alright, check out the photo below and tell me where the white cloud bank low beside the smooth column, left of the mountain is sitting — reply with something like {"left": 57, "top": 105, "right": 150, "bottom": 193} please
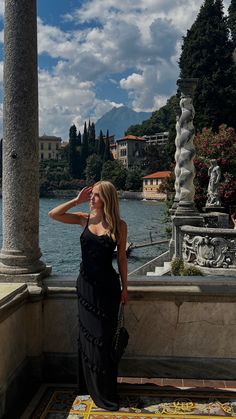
{"left": 39, "top": 71, "right": 121, "bottom": 139}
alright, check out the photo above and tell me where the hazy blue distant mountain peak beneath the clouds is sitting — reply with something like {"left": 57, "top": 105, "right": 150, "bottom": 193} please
{"left": 95, "top": 106, "right": 151, "bottom": 140}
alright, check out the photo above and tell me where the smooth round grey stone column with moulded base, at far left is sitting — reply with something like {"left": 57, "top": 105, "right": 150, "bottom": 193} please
{"left": 0, "top": 0, "right": 49, "bottom": 282}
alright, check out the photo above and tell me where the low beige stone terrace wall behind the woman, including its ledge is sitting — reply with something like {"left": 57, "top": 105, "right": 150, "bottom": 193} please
{"left": 0, "top": 276, "right": 236, "bottom": 417}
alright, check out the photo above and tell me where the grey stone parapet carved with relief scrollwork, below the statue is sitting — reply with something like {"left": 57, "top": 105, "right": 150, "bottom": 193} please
{"left": 181, "top": 226, "right": 236, "bottom": 269}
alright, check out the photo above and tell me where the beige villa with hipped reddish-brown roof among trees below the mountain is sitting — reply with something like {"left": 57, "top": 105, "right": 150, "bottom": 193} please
{"left": 116, "top": 135, "right": 146, "bottom": 169}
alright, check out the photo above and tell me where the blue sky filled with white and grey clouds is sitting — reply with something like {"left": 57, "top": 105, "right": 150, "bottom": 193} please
{"left": 0, "top": 0, "right": 230, "bottom": 140}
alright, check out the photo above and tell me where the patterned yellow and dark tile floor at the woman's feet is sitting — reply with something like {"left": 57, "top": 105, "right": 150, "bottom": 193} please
{"left": 21, "top": 377, "right": 236, "bottom": 419}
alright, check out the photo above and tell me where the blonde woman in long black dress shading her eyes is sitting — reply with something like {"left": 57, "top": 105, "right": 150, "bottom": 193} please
{"left": 49, "top": 181, "right": 128, "bottom": 410}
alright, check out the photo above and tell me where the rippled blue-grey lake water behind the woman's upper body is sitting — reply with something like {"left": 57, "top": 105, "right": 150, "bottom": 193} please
{"left": 0, "top": 198, "right": 167, "bottom": 275}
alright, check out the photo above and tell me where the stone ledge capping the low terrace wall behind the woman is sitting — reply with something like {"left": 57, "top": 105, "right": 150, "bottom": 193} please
{"left": 0, "top": 275, "right": 236, "bottom": 321}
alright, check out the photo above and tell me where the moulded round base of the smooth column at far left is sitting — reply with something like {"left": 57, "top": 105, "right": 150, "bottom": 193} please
{"left": 0, "top": 263, "right": 52, "bottom": 285}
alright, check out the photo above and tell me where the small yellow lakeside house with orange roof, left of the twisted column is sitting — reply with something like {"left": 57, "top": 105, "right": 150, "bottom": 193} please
{"left": 143, "top": 170, "right": 171, "bottom": 200}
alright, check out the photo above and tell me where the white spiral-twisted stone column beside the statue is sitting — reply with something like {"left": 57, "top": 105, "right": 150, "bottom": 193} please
{"left": 169, "top": 79, "right": 203, "bottom": 258}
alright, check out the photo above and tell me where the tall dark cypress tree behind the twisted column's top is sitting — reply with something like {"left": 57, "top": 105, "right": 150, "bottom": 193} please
{"left": 179, "top": 0, "right": 236, "bottom": 131}
